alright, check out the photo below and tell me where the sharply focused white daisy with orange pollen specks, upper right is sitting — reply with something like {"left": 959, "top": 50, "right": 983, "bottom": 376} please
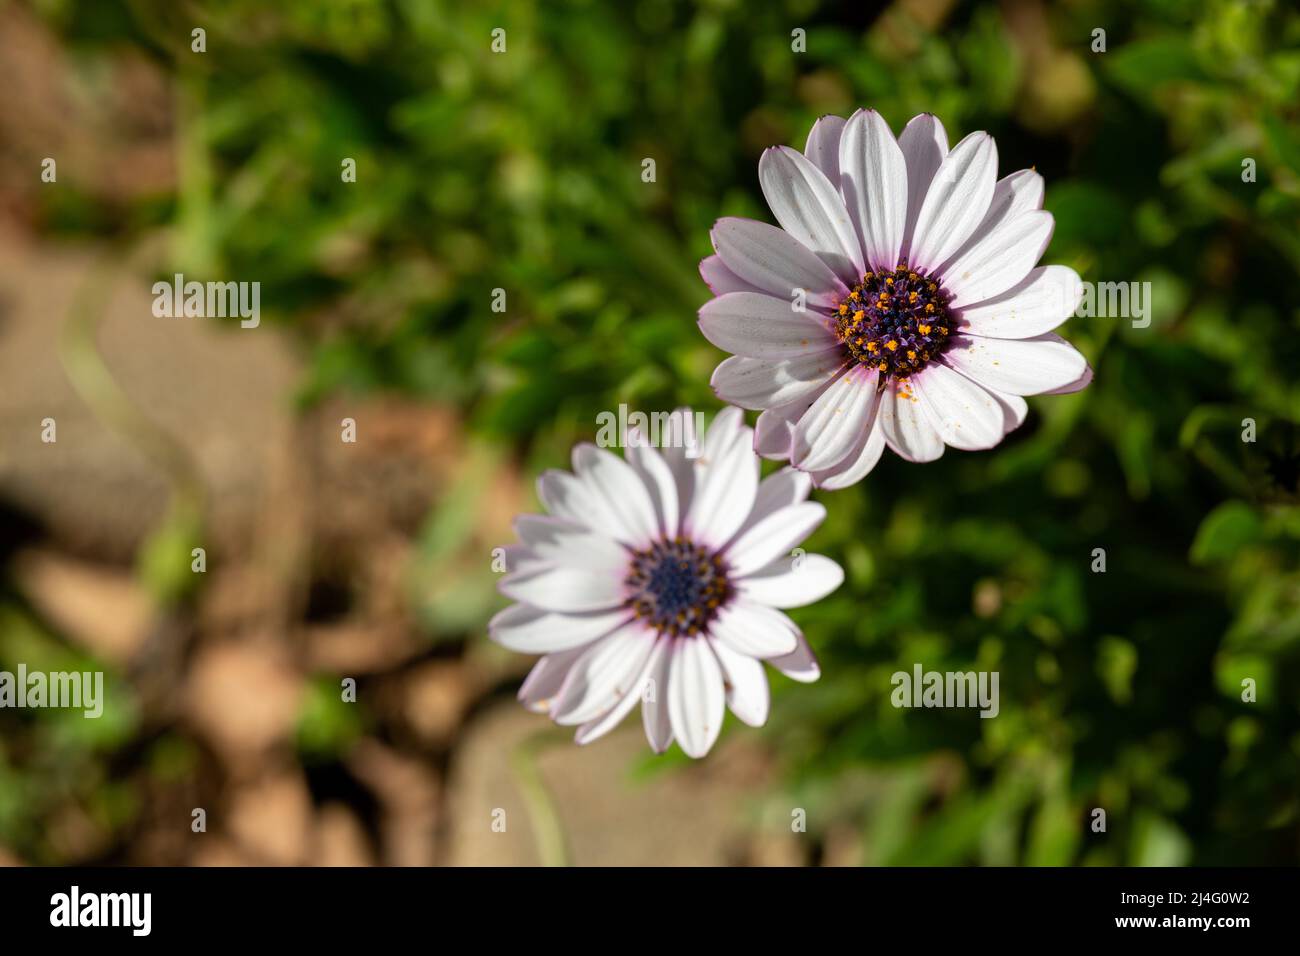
{"left": 699, "top": 111, "right": 1092, "bottom": 488}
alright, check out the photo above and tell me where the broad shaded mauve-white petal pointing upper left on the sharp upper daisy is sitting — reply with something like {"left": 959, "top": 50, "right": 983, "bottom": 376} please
{"left": 711, "top": 217, "right": 849, "bottom": 311}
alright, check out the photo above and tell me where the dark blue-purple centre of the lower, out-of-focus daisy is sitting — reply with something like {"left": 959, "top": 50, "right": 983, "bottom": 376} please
{"left": 624, "top": 537, "right": 731, "bottom": 637}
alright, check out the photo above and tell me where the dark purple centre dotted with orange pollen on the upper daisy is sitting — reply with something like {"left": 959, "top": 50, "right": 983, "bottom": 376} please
{"left": 835, "top": 263, "right": 952, "bottom": 389}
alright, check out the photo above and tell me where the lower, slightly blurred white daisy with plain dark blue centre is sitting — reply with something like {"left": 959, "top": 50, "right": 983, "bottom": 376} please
{"left": 489, "top": 408, "right": 844, "bottom": 757}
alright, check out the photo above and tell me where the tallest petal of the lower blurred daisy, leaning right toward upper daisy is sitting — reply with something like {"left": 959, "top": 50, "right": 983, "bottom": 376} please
{"left": 685, "top": 408, "right": 759, "bottom": 548}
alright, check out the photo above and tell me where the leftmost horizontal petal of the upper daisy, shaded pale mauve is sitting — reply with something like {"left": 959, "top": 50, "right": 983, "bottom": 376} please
{"left": 699, "top": 293, "right": 839, "bottom": 359}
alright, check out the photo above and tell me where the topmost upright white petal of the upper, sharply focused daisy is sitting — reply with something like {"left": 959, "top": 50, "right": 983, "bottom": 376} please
{"left": 840, "top": 109, "right": 907, "bottom": 269}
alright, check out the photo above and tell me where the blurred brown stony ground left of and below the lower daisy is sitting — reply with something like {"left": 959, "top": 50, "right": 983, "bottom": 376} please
{"left": 0, "top": 226, "right": 797, "bottom": 865}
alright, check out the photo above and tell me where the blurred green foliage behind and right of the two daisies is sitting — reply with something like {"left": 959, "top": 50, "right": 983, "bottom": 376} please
{"left": 17, "top": 0, "right": 1300, "bottom": 864}
